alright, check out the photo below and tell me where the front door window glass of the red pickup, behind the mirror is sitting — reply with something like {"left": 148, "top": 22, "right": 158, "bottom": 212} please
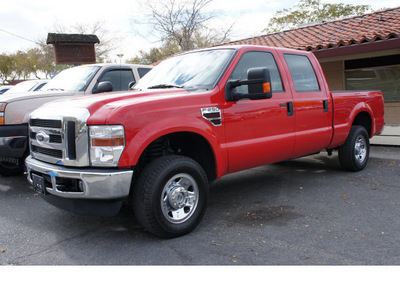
{"left": 229, "top": 51, "right": 284, "bottom": 94}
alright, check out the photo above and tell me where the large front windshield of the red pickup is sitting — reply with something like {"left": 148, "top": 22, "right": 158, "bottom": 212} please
{"left": 135, "top": 49, "right": 235, "bottom": 89}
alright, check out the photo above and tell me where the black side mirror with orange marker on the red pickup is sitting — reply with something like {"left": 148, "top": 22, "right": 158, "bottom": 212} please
{"left": 225, "top": 68, "right": 272, "bottom": 101}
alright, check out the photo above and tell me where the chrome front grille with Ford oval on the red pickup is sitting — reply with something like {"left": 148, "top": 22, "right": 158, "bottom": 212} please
{"left": 29, "top": 109, "right": 89, "bottom": 167}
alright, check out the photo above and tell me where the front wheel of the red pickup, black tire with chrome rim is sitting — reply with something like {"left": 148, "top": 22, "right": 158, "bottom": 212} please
{"left": 133, "top": 155, "right": 208, "bottom": 238}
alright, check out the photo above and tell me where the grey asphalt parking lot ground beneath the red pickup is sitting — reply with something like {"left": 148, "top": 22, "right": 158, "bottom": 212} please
{"left": 0, "top": 146, "right": 400, "bottom": 266}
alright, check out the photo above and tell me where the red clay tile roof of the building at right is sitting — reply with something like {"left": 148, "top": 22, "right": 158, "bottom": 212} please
{"left": 220, "top": 7, "right": 400, "bottom": 51}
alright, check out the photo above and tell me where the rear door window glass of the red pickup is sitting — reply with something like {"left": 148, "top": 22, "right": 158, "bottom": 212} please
{"left": 284, "top": 54, "right": 320, "bottom": 92}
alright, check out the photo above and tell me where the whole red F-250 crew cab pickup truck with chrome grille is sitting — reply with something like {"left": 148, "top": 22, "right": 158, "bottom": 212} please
{"left": 26, "top": 46, "right": 384, "bottom": 238}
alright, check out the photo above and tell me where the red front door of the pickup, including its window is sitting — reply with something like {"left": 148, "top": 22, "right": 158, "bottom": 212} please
{"left": 223, "top": 51, "right": 295, "bottom": 173}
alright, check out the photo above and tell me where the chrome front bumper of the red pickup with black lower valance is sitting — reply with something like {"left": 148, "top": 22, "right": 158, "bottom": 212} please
{"left": 25, "top": 156, "right": 133, "bottom": 216}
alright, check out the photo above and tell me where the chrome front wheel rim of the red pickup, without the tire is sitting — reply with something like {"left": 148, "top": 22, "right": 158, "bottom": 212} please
{"left": 161, "top": 173, "right": 199, "bottom": 224}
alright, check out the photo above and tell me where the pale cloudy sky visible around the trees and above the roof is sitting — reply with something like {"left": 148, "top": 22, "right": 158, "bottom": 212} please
{"left": 0, "top": 0, "right": 399, "bottom": 62}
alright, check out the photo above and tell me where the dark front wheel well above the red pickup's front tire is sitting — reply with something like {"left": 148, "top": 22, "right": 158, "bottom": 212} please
{"left": 136, "top": 132, "right": 217, "bottom": 181}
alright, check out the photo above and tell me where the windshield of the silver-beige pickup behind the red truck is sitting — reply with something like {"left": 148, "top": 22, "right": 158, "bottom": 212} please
{"left": 40, "top": 66, "right": 100, "bottom": 92}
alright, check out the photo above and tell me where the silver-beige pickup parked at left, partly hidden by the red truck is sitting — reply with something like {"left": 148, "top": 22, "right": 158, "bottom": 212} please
{"left": 0, "top": 64, "right": 152, "bottom": 176}
